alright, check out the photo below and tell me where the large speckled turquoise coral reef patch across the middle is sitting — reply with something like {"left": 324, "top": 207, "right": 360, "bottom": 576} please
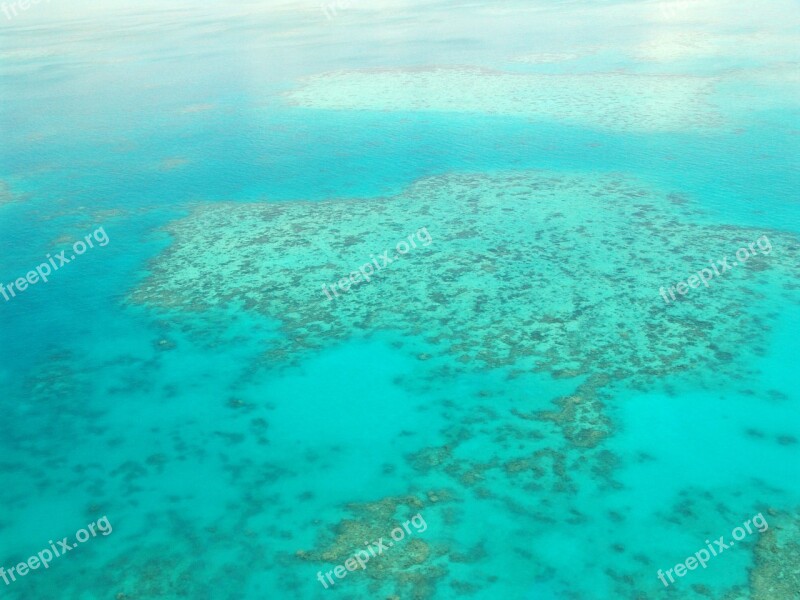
{"left": 132, "top": 172, "right": 800, "bottom": 446}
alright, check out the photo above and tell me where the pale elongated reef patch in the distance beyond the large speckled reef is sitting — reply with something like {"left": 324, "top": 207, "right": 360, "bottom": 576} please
{"left": 287, "top": 67, "right": 722, "bottom": 132}
